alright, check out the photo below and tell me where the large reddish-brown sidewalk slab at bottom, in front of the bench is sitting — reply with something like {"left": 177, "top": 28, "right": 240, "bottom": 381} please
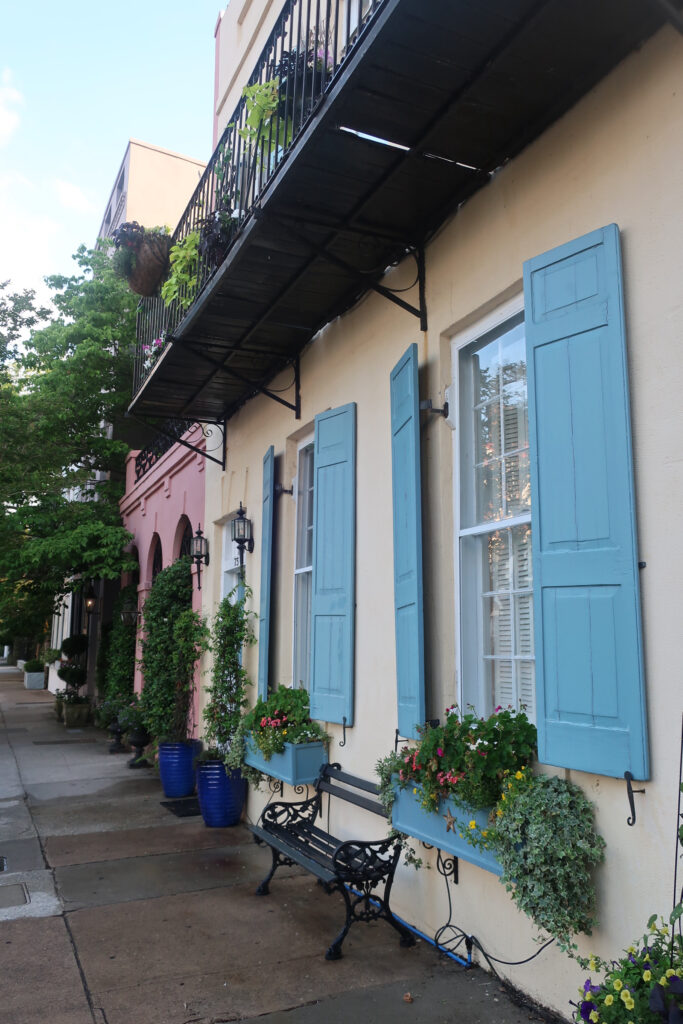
{"left": 69, "top": 876, "right": 444, "bottom": 1024}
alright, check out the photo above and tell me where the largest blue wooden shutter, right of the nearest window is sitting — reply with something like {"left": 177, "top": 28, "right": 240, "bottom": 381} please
{"left": 524, "top": 224, "right": 648, "bottom": 779}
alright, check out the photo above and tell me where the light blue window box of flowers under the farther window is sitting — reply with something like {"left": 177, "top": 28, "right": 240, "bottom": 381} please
{"left": 229, "top": 686, "right": 330, "bottom": 785}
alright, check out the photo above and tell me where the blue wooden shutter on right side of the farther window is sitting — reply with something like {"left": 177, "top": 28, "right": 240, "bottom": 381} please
{"left": 310, "top": 403, "right": 355, "bottom": 725}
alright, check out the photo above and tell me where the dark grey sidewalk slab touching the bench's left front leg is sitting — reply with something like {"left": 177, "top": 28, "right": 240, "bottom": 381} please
{"left": 54, "top": 845, "right": 292, "bottom": 910}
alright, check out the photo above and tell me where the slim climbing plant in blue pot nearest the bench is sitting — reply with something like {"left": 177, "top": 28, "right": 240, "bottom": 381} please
{"left": 197, "top": 589, "right": 256, "bottom": 827}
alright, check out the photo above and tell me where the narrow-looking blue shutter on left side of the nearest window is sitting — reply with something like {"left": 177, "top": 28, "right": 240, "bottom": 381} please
{"left": 391, "top": 345, "right": 425, "bottom": 737}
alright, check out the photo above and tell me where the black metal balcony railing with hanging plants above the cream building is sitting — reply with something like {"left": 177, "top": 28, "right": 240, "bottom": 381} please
{"left": 134, "top": 0, "right": 378, "bottom": 393}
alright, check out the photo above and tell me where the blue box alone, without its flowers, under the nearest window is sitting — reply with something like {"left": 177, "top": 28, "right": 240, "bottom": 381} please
{"left": 391, "top": 788, "right": 503, "bottom": 874}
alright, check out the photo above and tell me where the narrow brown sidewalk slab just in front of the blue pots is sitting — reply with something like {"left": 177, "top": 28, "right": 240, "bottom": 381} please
{"left": 46, "top": 817, "right": 251, "bottom": 867}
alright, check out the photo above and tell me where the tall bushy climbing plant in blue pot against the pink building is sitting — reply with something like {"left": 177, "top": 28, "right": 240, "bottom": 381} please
{"left": 140, "top": 557, "right": 208, "bottom": 798}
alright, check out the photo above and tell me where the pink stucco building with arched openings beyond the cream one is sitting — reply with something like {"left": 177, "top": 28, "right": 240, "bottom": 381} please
{"left": 120, "top": 423, "right": 206, "bottom": 734}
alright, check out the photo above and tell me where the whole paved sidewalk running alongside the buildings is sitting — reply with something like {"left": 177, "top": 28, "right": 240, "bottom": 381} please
{"left": 0, "top": 667, "right": 557, "bottom": 1024}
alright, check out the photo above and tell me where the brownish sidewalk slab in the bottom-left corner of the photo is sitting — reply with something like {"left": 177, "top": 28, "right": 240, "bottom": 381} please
{"left": 0, "top": 918, "right": 92, "bottom": 1024}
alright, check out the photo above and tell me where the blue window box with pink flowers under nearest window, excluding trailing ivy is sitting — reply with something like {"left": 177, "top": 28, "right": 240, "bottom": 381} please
{"left": 391, "top": 705, "right": 536, "bottom": 874}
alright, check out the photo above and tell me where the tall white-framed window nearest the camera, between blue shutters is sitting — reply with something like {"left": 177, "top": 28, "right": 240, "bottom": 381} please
{"left": 453, "top": 296, "right": 536, "bottom": 720}
